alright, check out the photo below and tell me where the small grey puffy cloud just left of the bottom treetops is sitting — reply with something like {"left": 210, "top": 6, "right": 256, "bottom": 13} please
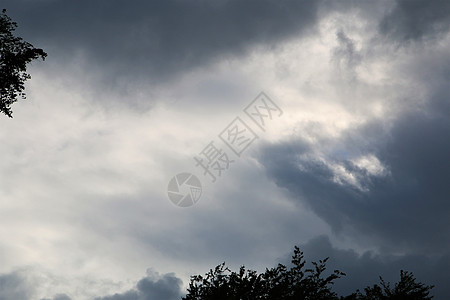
{"left": 95, "top": 273, "right": 183, "bottom": 300}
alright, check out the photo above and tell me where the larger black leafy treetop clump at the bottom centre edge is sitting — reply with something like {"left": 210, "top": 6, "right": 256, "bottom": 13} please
{"left": 183, "top": 247, "right": 345, "bottom": 300}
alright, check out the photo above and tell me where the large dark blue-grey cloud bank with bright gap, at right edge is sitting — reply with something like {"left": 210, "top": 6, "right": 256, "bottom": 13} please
{"left": 260, "top": 99, "right": 450, "bottom": 253}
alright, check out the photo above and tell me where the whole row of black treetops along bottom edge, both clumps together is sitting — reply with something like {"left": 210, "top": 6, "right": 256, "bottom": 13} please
{"left": 183, "top": 247, "right": 433, "bottom": 300}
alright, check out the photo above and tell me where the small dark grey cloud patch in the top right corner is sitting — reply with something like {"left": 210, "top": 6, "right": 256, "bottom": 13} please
{"left": 380, "top": 0, "right": 450, "bottom": 42}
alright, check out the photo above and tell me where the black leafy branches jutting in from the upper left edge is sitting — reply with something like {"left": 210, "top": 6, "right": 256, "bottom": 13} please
{"left": 0, "top": 9, "right": 47, "bottom": 118}
